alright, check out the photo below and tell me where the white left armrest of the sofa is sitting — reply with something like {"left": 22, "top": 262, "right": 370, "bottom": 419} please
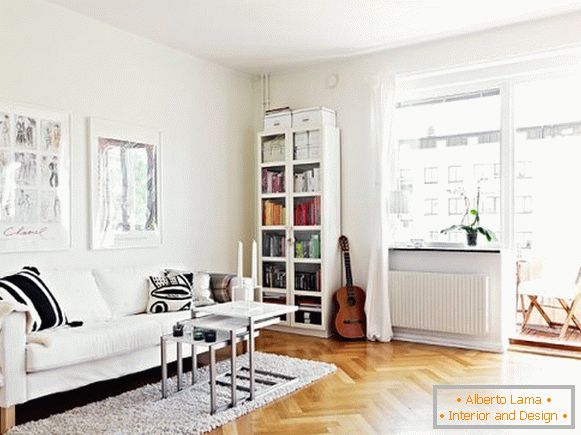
{"left": 0, "top": 312, "right": 26, "bottom": 408}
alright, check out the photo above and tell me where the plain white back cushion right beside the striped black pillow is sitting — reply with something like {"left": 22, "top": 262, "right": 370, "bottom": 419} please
{"left": 42, "top": 269, "right": 113, "bottom": 324}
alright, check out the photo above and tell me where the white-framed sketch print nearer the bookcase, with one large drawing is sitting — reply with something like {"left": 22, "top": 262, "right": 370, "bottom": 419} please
{"left": 89, "top": 118, "right": 161, "bottom": 249}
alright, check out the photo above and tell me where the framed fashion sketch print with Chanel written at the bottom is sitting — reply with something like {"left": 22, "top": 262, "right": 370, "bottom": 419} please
{"left": 0, "top": 102, "right": 70, "bottom": 253}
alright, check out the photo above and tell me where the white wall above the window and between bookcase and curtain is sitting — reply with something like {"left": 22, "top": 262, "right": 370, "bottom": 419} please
{"left": 271, "top": 13, "right": 581, "bottom": 285}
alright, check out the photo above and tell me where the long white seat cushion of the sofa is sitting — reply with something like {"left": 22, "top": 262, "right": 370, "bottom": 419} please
{"left": 26, "top": 316, "right": 162, "bottom": 373}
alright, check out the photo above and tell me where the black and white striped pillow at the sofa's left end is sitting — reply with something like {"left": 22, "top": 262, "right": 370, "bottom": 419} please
{"left": 0, "top": 267, "right": 67, "bottom": 332}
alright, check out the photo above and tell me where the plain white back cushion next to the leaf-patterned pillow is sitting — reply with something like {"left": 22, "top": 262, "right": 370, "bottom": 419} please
{"left": 94, "top": 266, "right": 162, "bottom": 317}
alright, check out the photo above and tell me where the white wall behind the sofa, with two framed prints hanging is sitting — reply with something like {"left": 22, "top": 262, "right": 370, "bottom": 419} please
{"left": 0, "top": 0, "right": 256, "bottom": 271}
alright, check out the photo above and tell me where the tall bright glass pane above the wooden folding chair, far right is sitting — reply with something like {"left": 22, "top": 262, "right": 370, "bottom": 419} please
{"left": 513, "top": 73, "right": 581, "bottom": 252}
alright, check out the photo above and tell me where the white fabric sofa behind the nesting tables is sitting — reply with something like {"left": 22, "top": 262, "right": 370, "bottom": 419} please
{"left": 0, "top": 266, "right": 231, "bottom": 427}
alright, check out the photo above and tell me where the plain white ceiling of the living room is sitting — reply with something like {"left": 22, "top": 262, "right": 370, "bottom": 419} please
{"left": 49, "top": 0, "right": 581, "bottom": 73}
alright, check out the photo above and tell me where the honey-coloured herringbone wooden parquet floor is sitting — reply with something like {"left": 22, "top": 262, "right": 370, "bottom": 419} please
{"left": 212, "top": 332, "right": 581, "bottom": 435}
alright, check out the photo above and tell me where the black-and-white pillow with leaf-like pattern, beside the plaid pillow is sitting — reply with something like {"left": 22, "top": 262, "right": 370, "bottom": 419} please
{"left": 147, "top": 275, "right": 192, "bottom": 313}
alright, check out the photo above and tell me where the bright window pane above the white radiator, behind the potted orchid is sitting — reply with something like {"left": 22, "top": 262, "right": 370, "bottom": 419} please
{"left": 393, "top": 89, "right": 500, "bottom": 243}
